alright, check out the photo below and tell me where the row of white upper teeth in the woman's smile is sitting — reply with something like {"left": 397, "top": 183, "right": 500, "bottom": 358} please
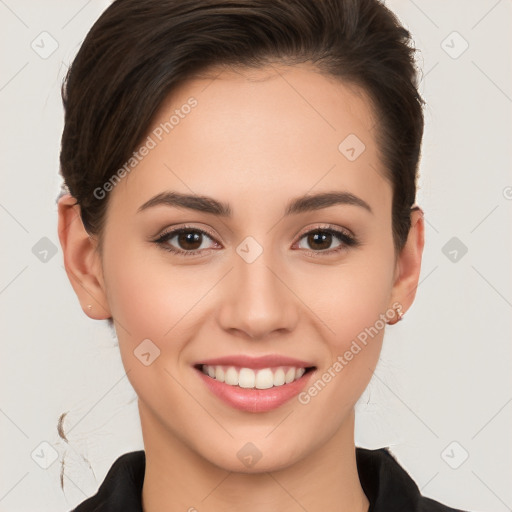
{"left": 202, "top": 364, "right": 306, "bottom": 389}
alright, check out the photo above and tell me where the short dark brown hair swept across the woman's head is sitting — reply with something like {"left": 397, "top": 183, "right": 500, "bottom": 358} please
{"left": 60, "top": 0, "right": 423, "bottom": 253}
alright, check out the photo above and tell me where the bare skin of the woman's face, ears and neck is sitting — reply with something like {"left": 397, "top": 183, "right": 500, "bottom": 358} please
{"left": 59, "top": 64, "right": 424, "bottom": 512}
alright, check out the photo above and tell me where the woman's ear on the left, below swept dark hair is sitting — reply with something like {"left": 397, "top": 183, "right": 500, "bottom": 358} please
{"left": 58, "top": 194, "right": 111, "bottom": 320}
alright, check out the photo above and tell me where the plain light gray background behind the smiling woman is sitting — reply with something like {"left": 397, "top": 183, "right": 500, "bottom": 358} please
{"left": 0, "top": 0, "right": 512, "bottom": 512}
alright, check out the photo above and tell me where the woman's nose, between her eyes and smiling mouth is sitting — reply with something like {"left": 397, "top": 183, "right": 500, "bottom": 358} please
{"left": 218, "top": 251, "right": 300, "bottom": 340}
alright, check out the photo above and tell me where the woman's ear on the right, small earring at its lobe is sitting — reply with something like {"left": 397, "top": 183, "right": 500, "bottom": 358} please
{"left": 390, "top": 207, "right": 425, "bottom": 313}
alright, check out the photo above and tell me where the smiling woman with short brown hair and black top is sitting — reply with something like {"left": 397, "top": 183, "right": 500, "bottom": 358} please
{"left": 59, "top": 0, "right": 470, "bottom": 512}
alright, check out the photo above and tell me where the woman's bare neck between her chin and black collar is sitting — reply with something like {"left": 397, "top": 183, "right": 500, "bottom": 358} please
{"left": 139, "top": 405, "right": 369, "bottom": 512}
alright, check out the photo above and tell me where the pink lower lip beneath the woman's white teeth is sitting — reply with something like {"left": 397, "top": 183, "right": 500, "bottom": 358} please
{"left": 194, "top": 368, "right": 315, "bottom": 412}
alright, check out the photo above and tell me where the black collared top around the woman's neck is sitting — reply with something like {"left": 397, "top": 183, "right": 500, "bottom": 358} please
{"left": 71, "top": 447, "right": 470, "bottom": 512}
